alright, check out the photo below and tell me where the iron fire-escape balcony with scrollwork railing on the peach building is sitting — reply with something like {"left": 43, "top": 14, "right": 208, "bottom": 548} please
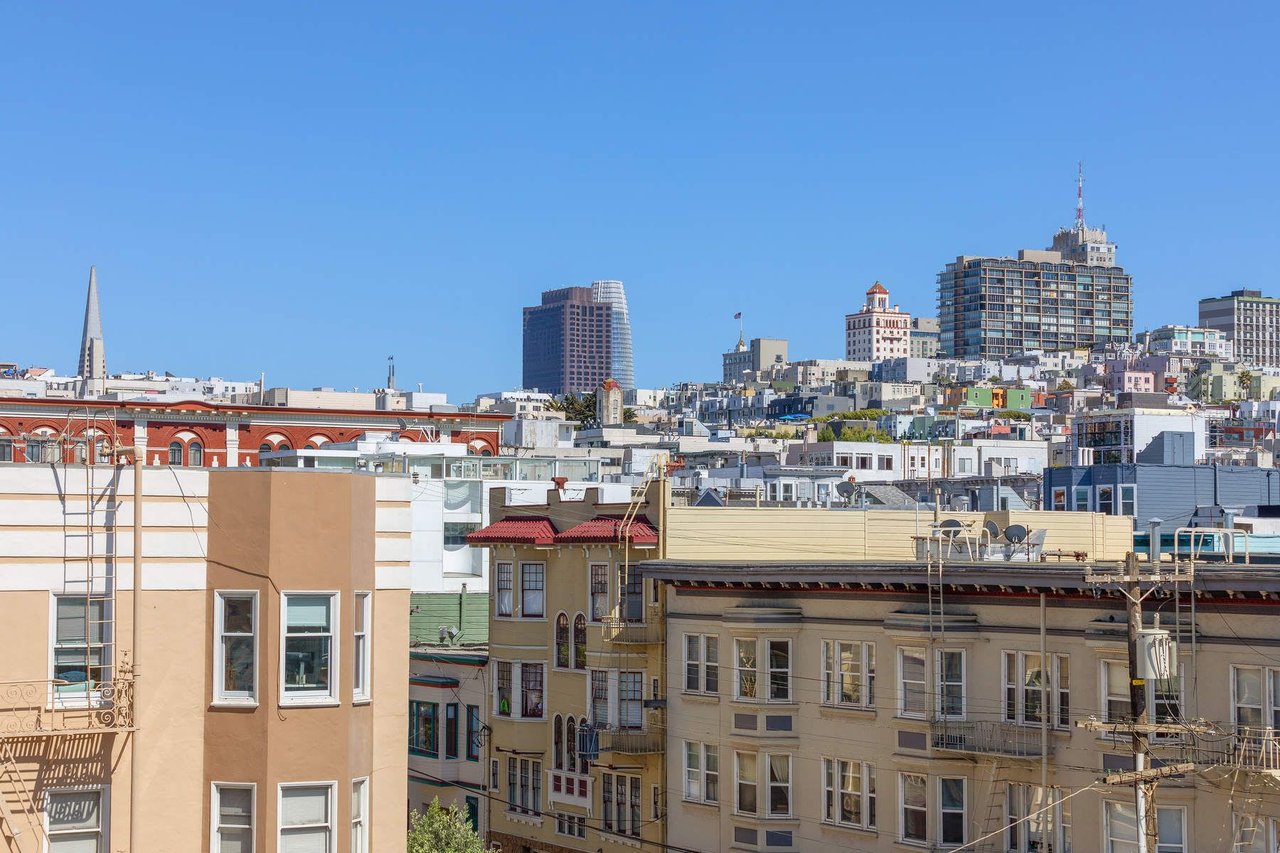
{"left": 0, "top": 679, "right": 133, "bottom": 736}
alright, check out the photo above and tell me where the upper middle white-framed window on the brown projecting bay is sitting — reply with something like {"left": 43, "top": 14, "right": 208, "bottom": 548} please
{"left": 280, "top": 593, "right": 338, "bottom": 704}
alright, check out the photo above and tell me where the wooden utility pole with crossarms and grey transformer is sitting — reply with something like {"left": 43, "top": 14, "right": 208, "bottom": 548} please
{"left": 1075, "top": 535, "right": 1208, "bottom": 853}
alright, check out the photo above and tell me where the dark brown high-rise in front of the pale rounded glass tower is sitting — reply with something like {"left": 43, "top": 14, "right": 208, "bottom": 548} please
{"left": 524, "top": 287, "right": 614, "bottom": 394}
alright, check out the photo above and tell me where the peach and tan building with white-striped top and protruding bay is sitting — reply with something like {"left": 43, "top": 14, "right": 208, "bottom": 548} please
{"left": 0, "top": 458, "right": 410, "bottom": 853}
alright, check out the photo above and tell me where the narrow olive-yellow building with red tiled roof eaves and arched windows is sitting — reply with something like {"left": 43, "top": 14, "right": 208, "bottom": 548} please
{"left": 468, "top": 487, "right": 666, "bottom": 853}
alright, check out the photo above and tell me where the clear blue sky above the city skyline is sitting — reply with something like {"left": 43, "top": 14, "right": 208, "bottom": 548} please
{"left": 0, "top": 1, "right": 1280, "bottom": 400}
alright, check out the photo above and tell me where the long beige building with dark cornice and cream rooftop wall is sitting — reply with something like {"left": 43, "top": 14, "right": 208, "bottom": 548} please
{"left": 643, "top": 507, "right": 1280, "bottom": 853}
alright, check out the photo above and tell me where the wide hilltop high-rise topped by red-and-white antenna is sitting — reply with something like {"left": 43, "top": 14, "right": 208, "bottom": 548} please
{"left": 938, "top": 171, "right": 1136, "bottom": 359}
